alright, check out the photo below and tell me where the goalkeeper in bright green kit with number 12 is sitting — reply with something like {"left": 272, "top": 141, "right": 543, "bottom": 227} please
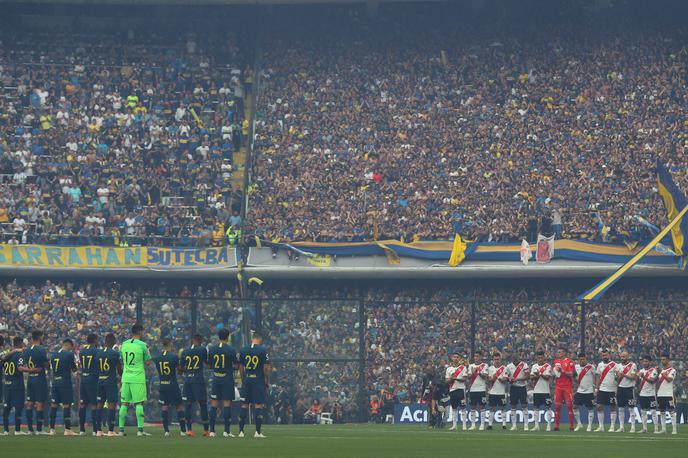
{"left": 119, "top": 323, "right": 151, "bottom": 436}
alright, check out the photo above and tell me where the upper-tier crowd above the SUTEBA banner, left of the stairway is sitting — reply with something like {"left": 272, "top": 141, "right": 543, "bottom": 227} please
{"left": 0, "top": 28, "right": 246, "bottom": 246}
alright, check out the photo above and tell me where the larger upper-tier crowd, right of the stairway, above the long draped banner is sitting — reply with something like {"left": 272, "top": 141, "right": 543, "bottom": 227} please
{"left": 247, "top": 13, "right": 688, "bottom": 242}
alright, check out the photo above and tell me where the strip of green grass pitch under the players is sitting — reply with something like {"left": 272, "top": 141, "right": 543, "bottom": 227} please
{"left": 0, "top": 424, "right": 688, "bottom": 458}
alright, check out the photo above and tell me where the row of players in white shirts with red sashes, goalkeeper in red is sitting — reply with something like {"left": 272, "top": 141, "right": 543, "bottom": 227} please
{"left": 426, "top": 348, "right": 677, "bottom": 434}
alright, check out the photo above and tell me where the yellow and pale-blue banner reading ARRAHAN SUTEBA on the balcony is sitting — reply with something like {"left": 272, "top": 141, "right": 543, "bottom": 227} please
{"left": 0, "top": 245, "right": 236, "bottom": 269}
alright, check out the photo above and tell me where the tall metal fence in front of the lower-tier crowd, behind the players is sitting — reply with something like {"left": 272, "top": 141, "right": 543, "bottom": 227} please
{"left": 136, "top": 297, "right": 688, "bottom": 421}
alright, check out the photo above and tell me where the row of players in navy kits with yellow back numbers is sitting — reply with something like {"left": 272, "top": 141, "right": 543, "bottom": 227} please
{"left": 0, "top": 329, "right": 270, "bottom": 437}
